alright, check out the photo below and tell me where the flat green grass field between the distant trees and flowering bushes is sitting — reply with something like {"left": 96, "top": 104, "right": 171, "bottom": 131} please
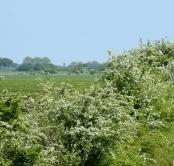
{"left": 0, "top": 73, "right": 96, "bottom": 93}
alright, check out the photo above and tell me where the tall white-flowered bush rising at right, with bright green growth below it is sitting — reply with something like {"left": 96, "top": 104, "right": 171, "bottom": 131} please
{"left": 101, "top": 41, "right": 174, "bottom": 166}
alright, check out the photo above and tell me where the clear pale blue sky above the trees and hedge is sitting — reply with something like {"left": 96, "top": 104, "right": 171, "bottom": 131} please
{"left": 0, "top": 0, "right": 174, "bottom": 65}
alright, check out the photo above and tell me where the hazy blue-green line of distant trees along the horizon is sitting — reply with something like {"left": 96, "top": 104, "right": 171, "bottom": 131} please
{"left": 0, "top": 56, "right": 106, "bottom": 74}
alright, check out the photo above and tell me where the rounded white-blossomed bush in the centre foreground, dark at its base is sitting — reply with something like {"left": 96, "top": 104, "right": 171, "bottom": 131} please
{"left": 49, "top": 86, "right": 134, "bottom": 165}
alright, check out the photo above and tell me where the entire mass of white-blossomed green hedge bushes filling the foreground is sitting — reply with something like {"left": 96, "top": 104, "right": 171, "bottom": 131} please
{"left": 0, "top": 41, "right": 174, "bottom": 166}
